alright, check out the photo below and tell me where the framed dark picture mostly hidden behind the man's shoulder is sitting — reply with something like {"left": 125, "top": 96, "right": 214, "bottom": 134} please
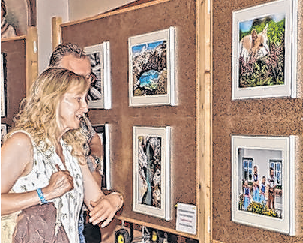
{"left": 93, "top": 123, "right": 112, "bottom": 190}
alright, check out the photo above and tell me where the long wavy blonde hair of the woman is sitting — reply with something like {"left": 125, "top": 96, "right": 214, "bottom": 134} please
{"left": 7, "top": 68, "right": 89, "bottom": 160}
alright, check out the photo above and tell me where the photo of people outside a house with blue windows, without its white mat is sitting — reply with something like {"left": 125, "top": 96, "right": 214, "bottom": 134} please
{"left": 237, "top": 148, "right": 283, "bottom": 218}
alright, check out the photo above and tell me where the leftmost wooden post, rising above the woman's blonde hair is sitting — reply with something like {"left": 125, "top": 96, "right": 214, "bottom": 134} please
{"left": 26, "top": 26, "right": 38, "bottom": 97}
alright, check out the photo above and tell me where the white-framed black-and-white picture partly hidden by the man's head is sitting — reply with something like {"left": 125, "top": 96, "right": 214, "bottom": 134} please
{"left": 84, "top": 41, "right": 112, "bottom": 109}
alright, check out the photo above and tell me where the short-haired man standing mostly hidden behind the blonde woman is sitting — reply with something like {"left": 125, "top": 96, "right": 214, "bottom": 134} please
{"left": 49, "top": 44, "right": 123, "bottom": 243}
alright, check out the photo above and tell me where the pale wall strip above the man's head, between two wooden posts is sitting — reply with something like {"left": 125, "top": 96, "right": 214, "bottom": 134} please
{"left": 37, "top": 0, "right": 69, "bottom": 73}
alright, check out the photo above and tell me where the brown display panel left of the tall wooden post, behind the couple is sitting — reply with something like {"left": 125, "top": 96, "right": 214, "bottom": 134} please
{"left": 62, "top": 0, "right": 196, "bottom": 229}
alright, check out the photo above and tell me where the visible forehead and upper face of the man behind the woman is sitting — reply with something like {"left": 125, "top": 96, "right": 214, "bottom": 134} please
{"left": 60, "top": 55, "right": 91, "bottom": 84}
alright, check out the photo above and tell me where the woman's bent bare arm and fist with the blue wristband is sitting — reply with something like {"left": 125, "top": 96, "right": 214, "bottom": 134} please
{"left": 1, "top": 132, "right": 73, "bottom": 215}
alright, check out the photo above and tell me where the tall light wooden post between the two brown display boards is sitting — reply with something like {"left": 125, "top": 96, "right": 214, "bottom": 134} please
{"left": 196, "top": 0, "right": 212, "bottom": 242}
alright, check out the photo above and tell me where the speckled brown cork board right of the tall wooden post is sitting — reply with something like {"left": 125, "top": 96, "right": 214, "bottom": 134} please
{"left": 212, "top": 0, "right": 303, "bottom": 243}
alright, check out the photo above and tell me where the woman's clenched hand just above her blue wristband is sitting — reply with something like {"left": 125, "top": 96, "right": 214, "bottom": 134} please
{"left": 42, "top": 164, "right": 74, "bottom": 200}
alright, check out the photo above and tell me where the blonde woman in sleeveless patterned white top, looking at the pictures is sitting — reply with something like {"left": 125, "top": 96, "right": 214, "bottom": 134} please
{"left": 1, "top": 68, "right": 123, "bottom": 243}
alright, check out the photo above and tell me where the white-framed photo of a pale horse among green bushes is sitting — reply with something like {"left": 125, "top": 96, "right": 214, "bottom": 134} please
{"left": 232, "top": 0, "right": 298, "bottom": 100}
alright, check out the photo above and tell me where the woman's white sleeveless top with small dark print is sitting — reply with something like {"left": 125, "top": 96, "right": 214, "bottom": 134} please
{"left": 13, "top": 131, "right": 83, "bottom": 243}
